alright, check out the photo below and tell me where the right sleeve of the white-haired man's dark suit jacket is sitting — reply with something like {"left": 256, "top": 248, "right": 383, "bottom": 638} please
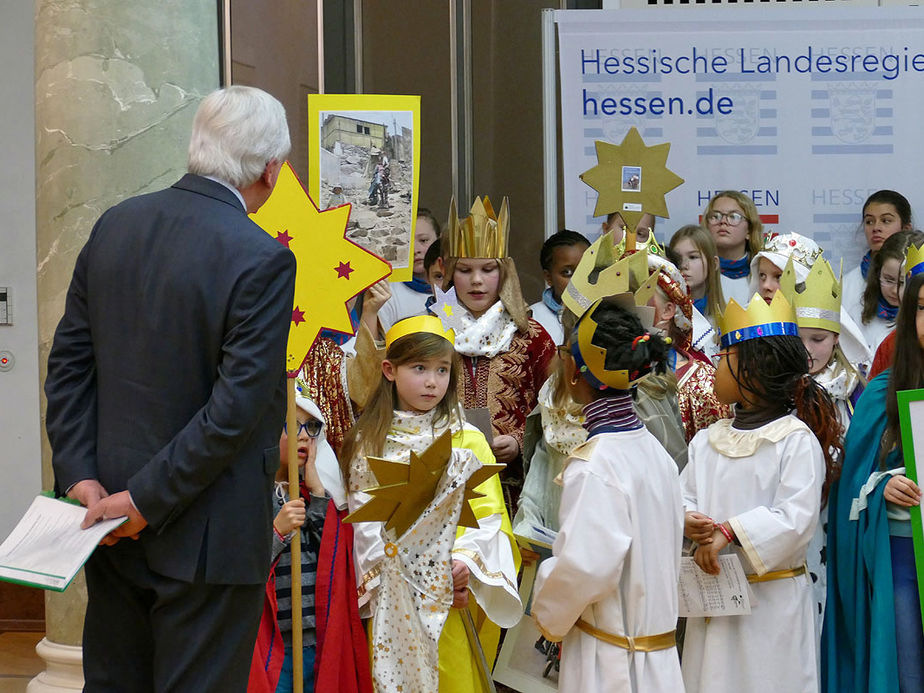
{"left": 128, "top": 252, "right": 295, "bottom": 530}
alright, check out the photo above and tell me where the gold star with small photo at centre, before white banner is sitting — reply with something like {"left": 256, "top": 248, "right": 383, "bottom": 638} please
{"left": 581, "top": 127, "right": 683, "bottom": 229}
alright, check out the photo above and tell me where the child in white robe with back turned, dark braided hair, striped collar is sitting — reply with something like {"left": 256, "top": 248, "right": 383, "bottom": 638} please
{"left": 532, "top": 298, "right": 683, "bottom": 693}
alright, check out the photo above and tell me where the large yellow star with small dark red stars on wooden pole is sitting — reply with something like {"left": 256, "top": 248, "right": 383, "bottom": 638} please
{"left": 250, "top": 162, "right": 391, "bottom": 375}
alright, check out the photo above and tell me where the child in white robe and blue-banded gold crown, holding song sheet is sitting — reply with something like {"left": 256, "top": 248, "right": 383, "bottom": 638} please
{"left": 680, "top": 292, "right": 841, "bottom": 693}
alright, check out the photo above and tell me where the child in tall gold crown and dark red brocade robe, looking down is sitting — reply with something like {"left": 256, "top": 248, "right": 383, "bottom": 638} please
{"left": 431, "top": 197, "right": 555, "bottom": 512}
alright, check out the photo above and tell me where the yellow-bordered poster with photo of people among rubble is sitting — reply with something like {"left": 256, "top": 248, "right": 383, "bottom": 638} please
{"left": 308, "top": 94, "right": 420, "bottom": 282}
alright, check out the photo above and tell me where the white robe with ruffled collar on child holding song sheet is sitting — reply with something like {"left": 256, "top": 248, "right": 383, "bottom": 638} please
{"left": 680, "top": 415, "right": 825, "bottom": 693}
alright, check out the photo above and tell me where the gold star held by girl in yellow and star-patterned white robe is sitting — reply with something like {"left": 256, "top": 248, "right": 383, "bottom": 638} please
{"left": 343, "top": 430, "right": 504, "bottom": 537}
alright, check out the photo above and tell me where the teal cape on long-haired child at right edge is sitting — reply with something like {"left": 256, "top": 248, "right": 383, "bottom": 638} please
{"left": 821, "top": 370, "right": 901, "bottom": 693}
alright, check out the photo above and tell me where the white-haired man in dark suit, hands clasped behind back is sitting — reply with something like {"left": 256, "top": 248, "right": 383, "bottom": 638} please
{"left": 45, "top": 87, "right": 295, "bottom": 693}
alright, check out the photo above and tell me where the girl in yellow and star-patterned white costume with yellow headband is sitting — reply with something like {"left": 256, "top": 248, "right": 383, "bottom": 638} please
{"left": 341, "top": 316, "right": 522, "bottom": 693}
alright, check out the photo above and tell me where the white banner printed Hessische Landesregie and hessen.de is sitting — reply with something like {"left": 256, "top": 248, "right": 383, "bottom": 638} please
{"left": 556, "top": 5, "right": 924, "bottom": 272}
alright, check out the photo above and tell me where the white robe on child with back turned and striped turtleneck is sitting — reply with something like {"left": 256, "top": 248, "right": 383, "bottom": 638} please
{"left": 532, "top": 428, "right": 683, "bottom": 693}
